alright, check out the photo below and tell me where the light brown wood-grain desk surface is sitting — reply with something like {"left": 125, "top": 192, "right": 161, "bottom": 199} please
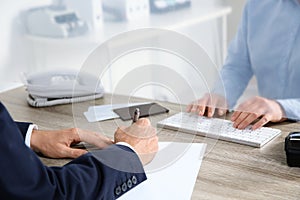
{"left": 0, "top": 88, "right": 300, "bottom": 199}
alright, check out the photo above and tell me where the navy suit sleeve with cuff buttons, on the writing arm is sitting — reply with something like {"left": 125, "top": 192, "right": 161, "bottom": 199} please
{"left": 0, "top": 103, "right": 146, "bottom": 200}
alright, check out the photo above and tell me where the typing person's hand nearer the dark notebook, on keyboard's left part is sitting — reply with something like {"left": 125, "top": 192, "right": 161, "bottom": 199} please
{"left": 187, "top": 93, "right": 228, "bottom": 117}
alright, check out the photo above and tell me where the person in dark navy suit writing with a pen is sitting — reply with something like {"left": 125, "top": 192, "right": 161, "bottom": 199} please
{"left": 0, "top": 103, "right": 158, "bottom": 200}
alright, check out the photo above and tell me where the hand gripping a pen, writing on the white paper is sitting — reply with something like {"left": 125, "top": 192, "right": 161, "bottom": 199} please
{"left": 115, "top": 118, "right": 158, "bottom": 165}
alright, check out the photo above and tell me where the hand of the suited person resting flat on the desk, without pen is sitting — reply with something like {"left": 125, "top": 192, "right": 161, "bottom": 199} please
{"left": 30, "top": 128, "right": 113, "bottom": 158}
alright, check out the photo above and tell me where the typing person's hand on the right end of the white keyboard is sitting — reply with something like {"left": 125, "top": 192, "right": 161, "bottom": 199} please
{"left": 231, "top": 97, "right": 286, "bottom": 130}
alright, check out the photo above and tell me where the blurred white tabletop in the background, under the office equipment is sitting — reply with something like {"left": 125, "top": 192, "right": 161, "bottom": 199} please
{"left": 26, "top": 1, "right": 232, "bottom": 45}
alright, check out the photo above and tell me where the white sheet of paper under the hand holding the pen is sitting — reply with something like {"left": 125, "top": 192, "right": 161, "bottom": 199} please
{"left": 119, "top": 142, "right": 206, "bottom": 200}
